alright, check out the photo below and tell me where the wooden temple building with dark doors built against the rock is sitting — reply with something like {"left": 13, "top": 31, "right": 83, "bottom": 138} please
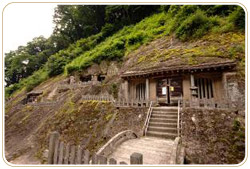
{"left": 121, "top": 57, "right": 237, "bottom": 106}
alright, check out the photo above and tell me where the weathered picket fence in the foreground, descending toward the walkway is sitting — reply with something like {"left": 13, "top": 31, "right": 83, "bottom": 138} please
{"left": 48, "top": 132, "right": 143, "bottom": 165}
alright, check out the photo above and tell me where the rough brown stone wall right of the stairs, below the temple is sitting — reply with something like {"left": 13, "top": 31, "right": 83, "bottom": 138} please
{"left": 182, "top": 108, "right": 245, "bottom": 164}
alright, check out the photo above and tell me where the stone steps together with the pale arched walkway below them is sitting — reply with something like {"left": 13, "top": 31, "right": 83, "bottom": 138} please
{"left": 99, "top": 107, "right": 185, "bottom": 165}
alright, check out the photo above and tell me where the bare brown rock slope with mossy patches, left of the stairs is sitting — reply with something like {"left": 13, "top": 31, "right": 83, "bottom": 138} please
{"left": 5, "top": 74, "right": 146, "bottom": 164}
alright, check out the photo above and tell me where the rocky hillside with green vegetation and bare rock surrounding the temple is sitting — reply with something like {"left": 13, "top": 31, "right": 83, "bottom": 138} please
{"left": 5, "top": 6, "right": 245, "bottom": 163}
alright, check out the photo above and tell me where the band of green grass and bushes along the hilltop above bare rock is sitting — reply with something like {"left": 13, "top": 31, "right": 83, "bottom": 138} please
{"left": 5, "top": 5, "right": 245, "bottom": 97}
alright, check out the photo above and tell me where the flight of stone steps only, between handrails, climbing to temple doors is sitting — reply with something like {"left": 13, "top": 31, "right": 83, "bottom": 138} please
{"left": 146, "top": 107, "right": 178, "bottom": 139}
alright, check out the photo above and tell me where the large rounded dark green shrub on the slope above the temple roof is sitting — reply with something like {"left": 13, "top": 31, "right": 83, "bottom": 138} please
{"left": 176, "top": 10, "right": 213, "bottom": 41}
